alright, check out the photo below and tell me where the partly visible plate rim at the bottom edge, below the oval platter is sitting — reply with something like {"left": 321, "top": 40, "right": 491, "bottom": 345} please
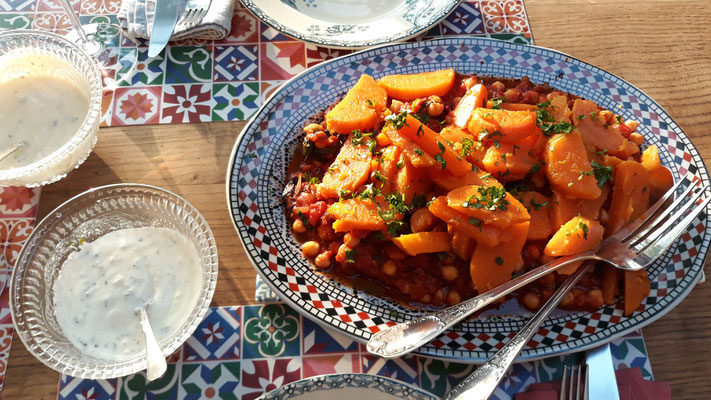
{"left": 258, "top": 374, "right": 436, "bottom": 400}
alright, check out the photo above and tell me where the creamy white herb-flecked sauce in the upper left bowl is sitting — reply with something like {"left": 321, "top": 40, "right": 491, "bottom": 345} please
{"left": 0, "top": 54, "right": 89, "bottom": 169}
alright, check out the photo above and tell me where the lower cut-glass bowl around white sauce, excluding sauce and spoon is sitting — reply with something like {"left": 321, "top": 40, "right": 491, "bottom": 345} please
{"left": 10, "top": 184, "right": 217, "bottom": 379}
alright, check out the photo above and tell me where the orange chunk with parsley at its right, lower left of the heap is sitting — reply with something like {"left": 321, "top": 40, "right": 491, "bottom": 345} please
{"left": 326, "top": 198, "right": 387, "bottom": 232}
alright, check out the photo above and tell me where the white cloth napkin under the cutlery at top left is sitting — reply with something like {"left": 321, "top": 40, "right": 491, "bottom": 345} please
{"left": 117, "top": 0, "right": 235, "bottom": 42}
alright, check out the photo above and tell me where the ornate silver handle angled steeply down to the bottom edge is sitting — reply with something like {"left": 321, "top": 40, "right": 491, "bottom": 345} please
{"left": 442, "top": 262, "right": 595, "bottom": 400}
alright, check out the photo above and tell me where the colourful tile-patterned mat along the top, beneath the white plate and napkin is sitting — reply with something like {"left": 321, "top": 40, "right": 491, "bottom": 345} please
{"left": 0, "top": 0, "right": 532, "bottom": 126}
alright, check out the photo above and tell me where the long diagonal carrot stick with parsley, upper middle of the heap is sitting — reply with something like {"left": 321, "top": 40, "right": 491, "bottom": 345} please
{"left": 398, "top": 114, "right": 471, "bottom": 176}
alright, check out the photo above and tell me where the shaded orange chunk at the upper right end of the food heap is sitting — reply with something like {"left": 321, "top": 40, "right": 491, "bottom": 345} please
{"left": 572, "top": 99, "right": 628, "bottom": 158}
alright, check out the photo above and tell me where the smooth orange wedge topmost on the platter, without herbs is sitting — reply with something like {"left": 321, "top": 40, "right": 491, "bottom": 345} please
{"left": 378, "top": 68, "right": 456, "bottom": 100}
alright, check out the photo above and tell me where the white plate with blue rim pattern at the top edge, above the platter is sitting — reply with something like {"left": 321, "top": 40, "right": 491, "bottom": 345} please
{"left": 242, "top": 0, "right": 459, "bottom": 49}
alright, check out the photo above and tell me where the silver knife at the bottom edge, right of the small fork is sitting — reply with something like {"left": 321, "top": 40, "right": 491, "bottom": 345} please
{"left": 585, "top": 343, "right": 620, "bottom": 400}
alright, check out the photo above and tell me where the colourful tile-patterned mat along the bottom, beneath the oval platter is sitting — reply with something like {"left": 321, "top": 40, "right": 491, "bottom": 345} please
{"left": 54, "top": 304, "right": 651, "bottom": 400}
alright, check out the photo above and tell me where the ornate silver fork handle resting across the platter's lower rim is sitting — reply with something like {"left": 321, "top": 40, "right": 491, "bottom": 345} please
{"left": 366, "top": 251, "right": 599, "bottom": 358}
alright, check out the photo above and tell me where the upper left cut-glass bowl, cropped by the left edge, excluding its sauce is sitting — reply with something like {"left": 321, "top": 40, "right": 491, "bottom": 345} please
{"left": 0, "top": 30, "right": 102, "bottom": 187}
